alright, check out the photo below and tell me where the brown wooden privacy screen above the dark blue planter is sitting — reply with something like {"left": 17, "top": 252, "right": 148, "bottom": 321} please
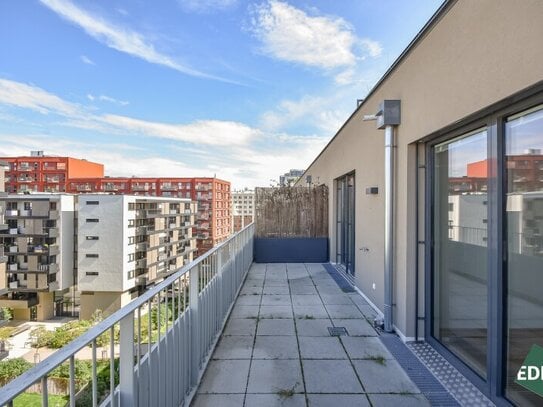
{"left": 255, "top": 185, "right": 328, "bottom": 238}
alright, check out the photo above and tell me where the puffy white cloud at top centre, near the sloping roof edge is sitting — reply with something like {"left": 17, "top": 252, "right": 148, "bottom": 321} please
{"left": 251, "top": 0, "right": 381, "bottom": 70}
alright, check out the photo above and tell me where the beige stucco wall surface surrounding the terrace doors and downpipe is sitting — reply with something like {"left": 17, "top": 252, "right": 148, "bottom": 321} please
{"left": 304, "top": 0, "right": 543, "bottom": 337}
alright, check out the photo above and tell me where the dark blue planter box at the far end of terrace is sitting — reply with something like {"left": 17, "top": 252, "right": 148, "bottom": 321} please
{"left": 254, "top": 237, "right": 329, "bottom": 263}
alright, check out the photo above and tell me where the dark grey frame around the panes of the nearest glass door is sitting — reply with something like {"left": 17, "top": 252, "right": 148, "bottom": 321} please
{"left": 419, "top": 87, "right": 543, "bottom": 406}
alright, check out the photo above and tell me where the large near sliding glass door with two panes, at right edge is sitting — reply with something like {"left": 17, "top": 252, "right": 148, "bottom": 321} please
{"left": 426, "top": 101, "right": 543, "bottom": 406}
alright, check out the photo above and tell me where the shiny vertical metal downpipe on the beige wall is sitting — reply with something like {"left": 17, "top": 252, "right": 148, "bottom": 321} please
{"left": 384, "top": 125, "right": 396, "bottom": 332}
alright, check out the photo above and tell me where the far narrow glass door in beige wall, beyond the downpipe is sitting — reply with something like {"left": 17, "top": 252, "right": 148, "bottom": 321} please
{"left": 336, "top": 173, "right": 355, "bottom": 274}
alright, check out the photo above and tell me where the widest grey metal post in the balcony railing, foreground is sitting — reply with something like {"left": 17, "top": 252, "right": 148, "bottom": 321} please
{"left": 119, "top": 312, "right": 135, "bottom": 406}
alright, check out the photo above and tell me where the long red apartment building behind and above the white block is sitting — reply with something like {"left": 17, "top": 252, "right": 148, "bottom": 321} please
{"left": 67, "top": 177, "right": 232, "bottom": 256}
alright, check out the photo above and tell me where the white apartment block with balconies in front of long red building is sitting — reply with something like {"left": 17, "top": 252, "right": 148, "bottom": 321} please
{"left": 77, "top": 194, "right": 196, "bottom": 318}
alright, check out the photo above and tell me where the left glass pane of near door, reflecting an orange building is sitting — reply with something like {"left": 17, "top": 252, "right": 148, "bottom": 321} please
{"left": 433, "top": 130, "right": 488, "bottom": 377}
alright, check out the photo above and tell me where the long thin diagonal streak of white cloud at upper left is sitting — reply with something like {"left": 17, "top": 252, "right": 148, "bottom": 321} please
{"left": 40, "top": 0, "right": 234, "bottom": 82}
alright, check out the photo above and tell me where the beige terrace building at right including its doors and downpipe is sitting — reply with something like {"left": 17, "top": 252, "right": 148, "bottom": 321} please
{"left": 298, "top": 0, "right": 543, "bottom": 406}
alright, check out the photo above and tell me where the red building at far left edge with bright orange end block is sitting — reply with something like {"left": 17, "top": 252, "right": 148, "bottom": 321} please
{"left": 0, "top": 151, "right": 104, "bottom": 193}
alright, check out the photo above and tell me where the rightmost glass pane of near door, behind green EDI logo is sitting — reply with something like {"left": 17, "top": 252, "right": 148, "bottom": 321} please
{"left": 505, "top": 108, "right": 543, "bottom": 406}
